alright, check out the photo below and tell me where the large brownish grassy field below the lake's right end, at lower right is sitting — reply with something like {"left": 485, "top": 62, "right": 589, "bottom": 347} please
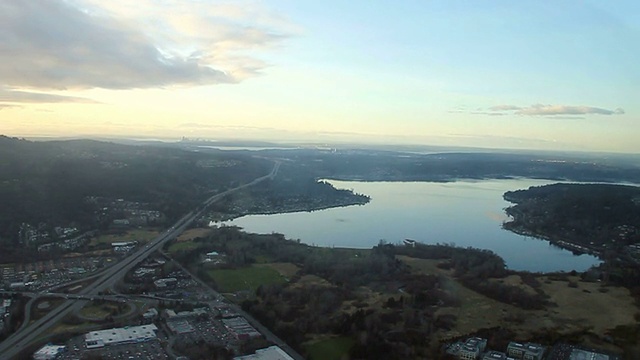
{"left": 398, "top": 256, "right": 639, "bottom": 338}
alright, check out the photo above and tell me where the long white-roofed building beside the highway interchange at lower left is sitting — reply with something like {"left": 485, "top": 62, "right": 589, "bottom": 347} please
{"left": 84, "top": 324, "right": 158, "bottom": 349}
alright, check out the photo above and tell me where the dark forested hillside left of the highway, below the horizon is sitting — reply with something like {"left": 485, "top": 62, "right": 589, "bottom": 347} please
{"left": 0, "top": 136, "right": 273, "bottom": 255}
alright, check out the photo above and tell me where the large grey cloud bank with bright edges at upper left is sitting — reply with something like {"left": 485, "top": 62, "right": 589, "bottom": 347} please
{"left": 0, "top": 0, "right": 286, "bottom": 89}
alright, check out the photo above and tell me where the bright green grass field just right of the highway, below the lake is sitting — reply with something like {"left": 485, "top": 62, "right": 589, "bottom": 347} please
{"left": 207, "top": 266, "right": 285, "bottom": 293}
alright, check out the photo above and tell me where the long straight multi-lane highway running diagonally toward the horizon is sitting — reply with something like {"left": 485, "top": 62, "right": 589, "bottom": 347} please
{"left": 0, "top": 162, "right": 280, "bottom": 360}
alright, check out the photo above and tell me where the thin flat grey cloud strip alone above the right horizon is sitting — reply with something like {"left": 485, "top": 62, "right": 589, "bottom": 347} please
{"left": 484, "top": 104, "right": 625, "bottom": 118}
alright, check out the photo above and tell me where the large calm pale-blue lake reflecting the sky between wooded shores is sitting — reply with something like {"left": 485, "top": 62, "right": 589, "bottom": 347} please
{"left": 220, "top": 179, "right": 600, "bottom": 272}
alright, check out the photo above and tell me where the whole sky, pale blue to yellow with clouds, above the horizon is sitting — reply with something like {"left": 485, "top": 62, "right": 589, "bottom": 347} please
{"left": 0, "top": 0, "right": 640, "bottom": 153}
